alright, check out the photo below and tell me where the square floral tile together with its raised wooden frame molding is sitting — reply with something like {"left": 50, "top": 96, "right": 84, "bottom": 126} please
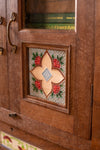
{"left": 23, "top": 44, "right": 70, "bottom": 112}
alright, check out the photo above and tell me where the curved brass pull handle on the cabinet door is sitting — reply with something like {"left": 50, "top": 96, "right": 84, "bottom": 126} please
{"left": 7, "top": 12, "right": 17, "bottom": 53}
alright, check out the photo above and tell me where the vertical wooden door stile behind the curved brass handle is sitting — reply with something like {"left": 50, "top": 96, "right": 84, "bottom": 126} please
{"left": 7, "top": 0, "right": 21, "bottom": 112}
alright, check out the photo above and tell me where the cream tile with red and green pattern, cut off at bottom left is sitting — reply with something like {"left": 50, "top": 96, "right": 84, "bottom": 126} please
{"left": 0, "top": 132, "right": 42, "bottom": 150}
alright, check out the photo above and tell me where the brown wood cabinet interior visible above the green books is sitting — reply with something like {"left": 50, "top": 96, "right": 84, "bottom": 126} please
{"left": 26, "top": 0, "right": 75, "bottom": 13}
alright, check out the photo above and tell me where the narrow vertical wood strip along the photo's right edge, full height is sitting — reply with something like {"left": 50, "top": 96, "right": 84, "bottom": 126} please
{"left": 92, "top": 0, "right": 100, "bottom": 150}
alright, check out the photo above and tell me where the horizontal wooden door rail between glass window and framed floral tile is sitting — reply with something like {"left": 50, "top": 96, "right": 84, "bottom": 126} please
{"left": 19, "top": 29, "right": 76, "bottom": 46}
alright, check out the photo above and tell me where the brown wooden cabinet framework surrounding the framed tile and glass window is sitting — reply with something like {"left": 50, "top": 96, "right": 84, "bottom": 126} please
{"left": 0, "top": 0, "right": 97, "bottom": 150}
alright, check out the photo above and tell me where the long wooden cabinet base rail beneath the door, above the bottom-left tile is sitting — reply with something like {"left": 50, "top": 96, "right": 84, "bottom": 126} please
{"left": 0, "top": 108, "right": 91, "bottom": 150}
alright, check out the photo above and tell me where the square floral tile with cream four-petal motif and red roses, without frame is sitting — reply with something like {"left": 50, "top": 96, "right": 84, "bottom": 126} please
{"left": 29, "top": 48, "right": 66, "bottom": 106}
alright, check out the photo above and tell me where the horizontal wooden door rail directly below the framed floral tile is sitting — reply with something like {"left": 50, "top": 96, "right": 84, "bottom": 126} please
{"left": 21, "top": 100, "right": 74, "bottom": 133}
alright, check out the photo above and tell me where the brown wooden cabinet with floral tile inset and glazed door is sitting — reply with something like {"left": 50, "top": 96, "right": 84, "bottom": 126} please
{"left": 0, "top": 0, "right": 95, "bottom": 150}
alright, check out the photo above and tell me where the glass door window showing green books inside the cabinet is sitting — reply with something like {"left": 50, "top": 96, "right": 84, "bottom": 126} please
{"left": 24, "top": 0, "right": 75, "bottom": 30}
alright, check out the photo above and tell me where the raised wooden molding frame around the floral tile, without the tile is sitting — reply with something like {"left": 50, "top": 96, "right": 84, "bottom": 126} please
{"left": 22, "top": 43, "right": 71, "bottom": 113}
